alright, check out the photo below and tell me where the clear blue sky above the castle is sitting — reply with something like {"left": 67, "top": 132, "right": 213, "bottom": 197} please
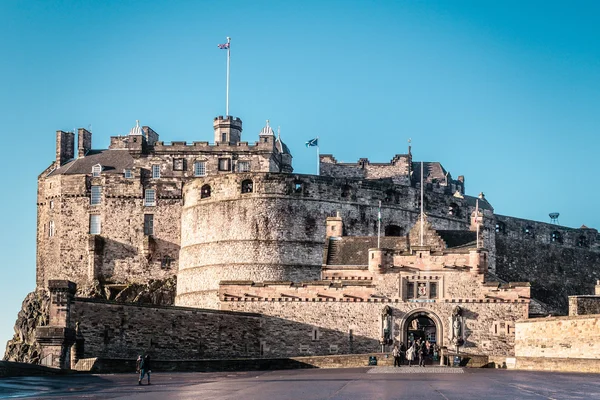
{"left": 0, "top": 0, "right": 600, "bottom": 350}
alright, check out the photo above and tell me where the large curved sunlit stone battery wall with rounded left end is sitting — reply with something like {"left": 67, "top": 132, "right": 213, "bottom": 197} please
{"left": 176, "top": 173, "right": 494, "bottom": 308}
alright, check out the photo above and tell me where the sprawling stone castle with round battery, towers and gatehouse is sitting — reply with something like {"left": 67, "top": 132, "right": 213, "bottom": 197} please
{"left": 8, "top": 116, "right": 600, "bottom": 366}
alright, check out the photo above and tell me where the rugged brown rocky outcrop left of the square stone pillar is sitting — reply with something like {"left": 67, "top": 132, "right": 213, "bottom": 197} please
{"left": 4, "top": 291, "right": 50, "bottom": 364}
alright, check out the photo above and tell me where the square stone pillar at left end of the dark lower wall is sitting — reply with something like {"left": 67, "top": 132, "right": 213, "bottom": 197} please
{"left": 35, "top": 280, "right": 77, "bottom": 369}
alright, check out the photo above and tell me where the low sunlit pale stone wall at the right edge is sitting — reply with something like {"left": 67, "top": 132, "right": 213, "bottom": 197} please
{"left": 515, "top": 314, "right": 600, "bottom": 359}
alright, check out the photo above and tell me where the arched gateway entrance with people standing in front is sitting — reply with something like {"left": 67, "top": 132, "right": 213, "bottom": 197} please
{"left": 398, "top": 308, "right": 444, "bottom": 346}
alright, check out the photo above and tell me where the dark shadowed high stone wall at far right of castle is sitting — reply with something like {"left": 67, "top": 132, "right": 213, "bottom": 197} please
{"left": 495, "top": 215, "right": 600, "bottom": 314}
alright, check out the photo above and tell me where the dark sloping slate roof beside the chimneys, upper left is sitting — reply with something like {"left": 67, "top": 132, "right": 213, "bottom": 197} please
{"left": 50, "top": 150, "right": 133, "bottom": 175}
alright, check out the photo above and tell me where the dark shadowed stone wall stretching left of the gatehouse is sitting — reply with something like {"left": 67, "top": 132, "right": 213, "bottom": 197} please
{"left": 70, "top": 298, "right": 261, "bottom": 360}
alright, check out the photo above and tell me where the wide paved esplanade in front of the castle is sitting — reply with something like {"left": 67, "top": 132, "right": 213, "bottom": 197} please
{"left": 0, "top": 367, "right": 600, "bottom": 400}
